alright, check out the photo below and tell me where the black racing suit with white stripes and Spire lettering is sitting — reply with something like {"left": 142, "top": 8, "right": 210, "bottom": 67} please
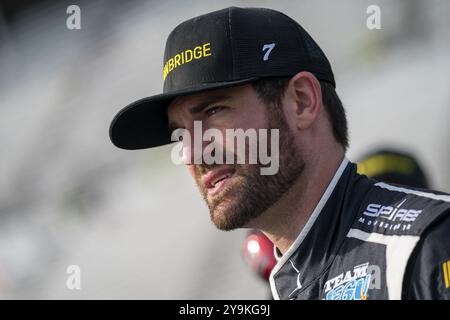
{"left": 270, "top": 159, "right": 450, "bottom": 300}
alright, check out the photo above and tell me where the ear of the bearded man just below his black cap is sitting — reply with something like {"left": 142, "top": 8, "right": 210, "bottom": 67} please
{"left": 286, "top": 71, "right": 322, "bottom": 130}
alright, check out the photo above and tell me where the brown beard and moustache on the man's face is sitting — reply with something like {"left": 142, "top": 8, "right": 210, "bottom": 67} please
{"left": 194, "top": 109, "right": 305, "bottom": 231}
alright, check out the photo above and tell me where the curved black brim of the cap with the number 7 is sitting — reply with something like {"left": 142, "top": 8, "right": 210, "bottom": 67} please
{"left": 109, "top": 78, "right": 258, "bottom": 150}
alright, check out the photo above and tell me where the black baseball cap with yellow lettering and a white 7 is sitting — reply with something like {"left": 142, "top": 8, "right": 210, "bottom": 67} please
{"left": 109, "top": 7, "right": 336, "bottom": 150}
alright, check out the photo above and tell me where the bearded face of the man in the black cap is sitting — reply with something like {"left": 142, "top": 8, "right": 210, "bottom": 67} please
{"left": 167, "top": 85, "right": 304, "bottom": 230}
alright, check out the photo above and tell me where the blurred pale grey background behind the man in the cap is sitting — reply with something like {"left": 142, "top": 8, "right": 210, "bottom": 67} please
{"left": 0, "top": 0, "right": 450, "bottom": 299}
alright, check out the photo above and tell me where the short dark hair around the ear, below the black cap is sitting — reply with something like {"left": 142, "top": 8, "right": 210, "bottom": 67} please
{"left": 252, "top": 77, "right": 348, "bottom": 149}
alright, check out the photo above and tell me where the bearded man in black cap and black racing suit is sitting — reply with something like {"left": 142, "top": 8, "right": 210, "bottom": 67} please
{"left": 110, "top": 7, "right": 450, "bottom": 299}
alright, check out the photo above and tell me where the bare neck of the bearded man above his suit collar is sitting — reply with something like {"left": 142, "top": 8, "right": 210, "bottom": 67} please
{"left": 251, "top": 149, "right": 344, "bottom": 254}
